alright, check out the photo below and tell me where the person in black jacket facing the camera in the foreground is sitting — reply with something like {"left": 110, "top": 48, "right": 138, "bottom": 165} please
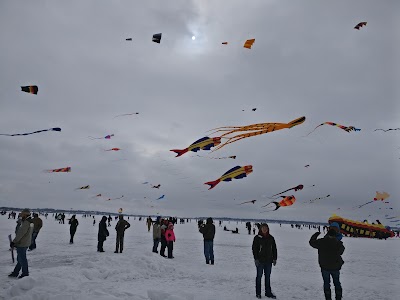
{"left": 252, "top": 223, "right": 278, "bottom": 299}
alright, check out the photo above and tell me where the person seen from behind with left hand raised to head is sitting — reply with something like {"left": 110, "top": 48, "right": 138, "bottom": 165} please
{"left": 310, "top": 227, "right": 345, "bottom": 300}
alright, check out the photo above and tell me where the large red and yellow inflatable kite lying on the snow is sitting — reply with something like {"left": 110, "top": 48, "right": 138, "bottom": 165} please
{"left": 328, "top": 214, "right": 394, "bottom": 238}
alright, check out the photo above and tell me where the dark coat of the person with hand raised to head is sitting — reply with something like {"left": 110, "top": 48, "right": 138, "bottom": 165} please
{"left": 310, "top": 232, "right": 345, "bottom": 270}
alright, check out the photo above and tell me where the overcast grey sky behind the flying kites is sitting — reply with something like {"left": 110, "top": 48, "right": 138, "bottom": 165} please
{"left": 0, "top": 0, "right": 400, "bottom": 221}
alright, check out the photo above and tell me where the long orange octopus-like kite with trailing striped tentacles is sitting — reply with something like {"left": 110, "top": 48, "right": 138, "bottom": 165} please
{"left": 208, "top": 117, "right": 306, "bottom": 152}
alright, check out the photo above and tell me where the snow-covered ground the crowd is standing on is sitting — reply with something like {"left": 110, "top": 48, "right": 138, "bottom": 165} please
{"left": 0, "top": 216, "right": 400, "bottom": 300}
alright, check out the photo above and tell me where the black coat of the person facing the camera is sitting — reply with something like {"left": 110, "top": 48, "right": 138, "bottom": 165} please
{"left": 252, "top": 233, "right": 278, "bottom": 263}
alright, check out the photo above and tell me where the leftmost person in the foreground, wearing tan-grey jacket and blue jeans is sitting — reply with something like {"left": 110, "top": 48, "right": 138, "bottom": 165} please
{"left": 8, "top": 208, "right": 34, "bottom": 278}
